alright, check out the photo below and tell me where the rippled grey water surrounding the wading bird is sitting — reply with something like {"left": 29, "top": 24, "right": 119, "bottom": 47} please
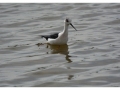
{"left": 0, "top": 3, "right": 120, "bottom": 87}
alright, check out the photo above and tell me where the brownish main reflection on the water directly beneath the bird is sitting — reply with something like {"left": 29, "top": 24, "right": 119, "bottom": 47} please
{"left": 46, "top": 44, "right": 72, "bottom": 63}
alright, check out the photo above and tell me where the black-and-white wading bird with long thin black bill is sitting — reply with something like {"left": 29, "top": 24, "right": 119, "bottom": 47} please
{"left": 41, "top": 18, "right": 77, "bottom": 45}
